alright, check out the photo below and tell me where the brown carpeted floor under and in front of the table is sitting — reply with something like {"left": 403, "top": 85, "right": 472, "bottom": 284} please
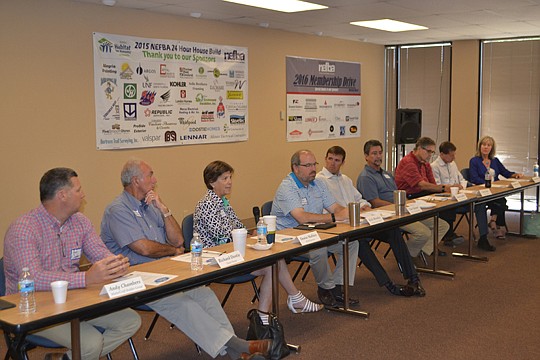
{"left": 0, "top": 215, "right": 540, "bottom": 360}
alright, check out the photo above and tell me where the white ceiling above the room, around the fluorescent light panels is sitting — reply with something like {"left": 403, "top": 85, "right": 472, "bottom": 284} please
{"left": 74, "top": 0, "right": 540, "bottom": 45}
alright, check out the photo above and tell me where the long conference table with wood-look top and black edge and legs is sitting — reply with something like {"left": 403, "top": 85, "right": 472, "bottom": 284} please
{"left": 0, "top": 179, "right": 540, "bottom": 360}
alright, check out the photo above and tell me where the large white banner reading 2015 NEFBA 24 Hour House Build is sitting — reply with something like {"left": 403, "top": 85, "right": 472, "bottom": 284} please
{"left": 93, "top": 33, "right": 248, "bottom": 149}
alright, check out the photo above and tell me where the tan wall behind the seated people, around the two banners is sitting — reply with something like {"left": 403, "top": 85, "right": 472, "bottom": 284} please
{"left": 0, "top": 0, "right": 384, "bottom": 252}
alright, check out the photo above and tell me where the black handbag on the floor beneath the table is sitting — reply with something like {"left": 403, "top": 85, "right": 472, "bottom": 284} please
{"left": 246, "top": 309, "right": 291, "bottom": 360}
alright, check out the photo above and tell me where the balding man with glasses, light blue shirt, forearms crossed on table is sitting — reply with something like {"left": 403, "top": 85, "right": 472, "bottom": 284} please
{"left": 272, "top": 150, "right": 358, "bottom": 306}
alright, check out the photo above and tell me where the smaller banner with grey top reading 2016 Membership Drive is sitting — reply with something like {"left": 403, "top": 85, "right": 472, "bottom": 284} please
{"left": 286, "top": 56, "right": 362, "bottom": 141}
